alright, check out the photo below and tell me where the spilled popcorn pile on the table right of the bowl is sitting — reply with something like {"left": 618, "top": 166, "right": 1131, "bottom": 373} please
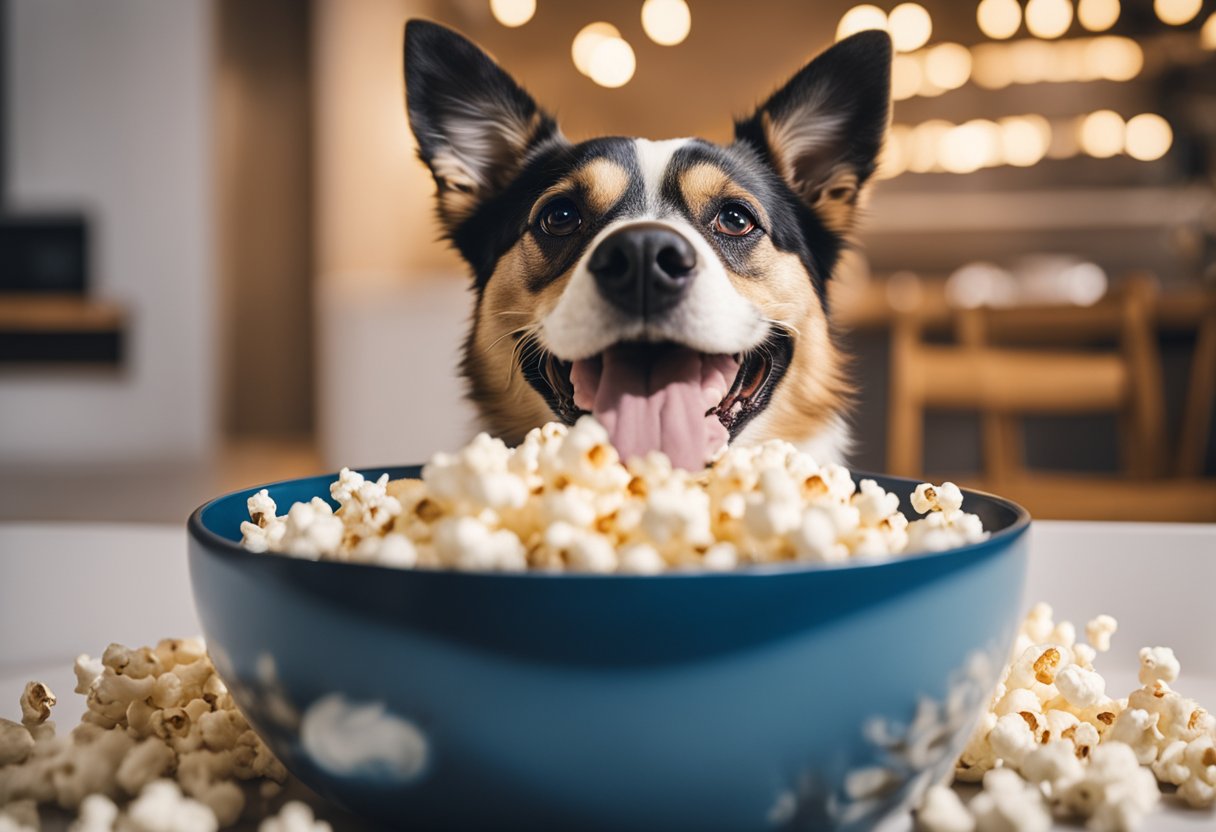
{"left": 917, "top": 603, "right": 1216, "bottom": 832}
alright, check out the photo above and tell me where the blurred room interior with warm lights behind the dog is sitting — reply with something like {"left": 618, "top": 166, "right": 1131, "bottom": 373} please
{"left": 0, "top": 0, "right": 1216, "bottom": 522}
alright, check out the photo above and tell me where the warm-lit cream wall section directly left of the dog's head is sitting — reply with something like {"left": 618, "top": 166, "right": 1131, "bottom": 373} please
{"left": 313, "top": 0, "right": 473, "bottom": 467}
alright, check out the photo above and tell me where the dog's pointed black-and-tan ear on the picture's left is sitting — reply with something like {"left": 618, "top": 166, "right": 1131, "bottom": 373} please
{"left": 405, "top": 21, "right": 561, "bottom": 234}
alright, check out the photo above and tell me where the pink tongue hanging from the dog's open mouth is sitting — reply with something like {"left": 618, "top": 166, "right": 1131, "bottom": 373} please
{"left": 570, "top": 345, "right": 739, "bottom": 471}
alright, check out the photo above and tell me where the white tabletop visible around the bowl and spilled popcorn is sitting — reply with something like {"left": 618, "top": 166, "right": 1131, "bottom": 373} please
{"left": 0, "top": 521, "right": 1216, "bottom": 832}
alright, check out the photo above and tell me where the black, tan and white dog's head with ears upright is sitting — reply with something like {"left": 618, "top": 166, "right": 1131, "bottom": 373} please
{"left": 405, "top": 21, "right": 890, "bottom": 467}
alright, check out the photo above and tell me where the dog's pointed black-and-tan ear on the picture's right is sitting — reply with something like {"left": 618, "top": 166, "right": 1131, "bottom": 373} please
{"left": 734, "top": 32, "right": 891, "bottom": 234}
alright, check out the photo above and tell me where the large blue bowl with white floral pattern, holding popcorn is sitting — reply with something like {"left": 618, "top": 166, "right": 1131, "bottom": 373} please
{"left": 190, "top": 467, "right": 1030, "bottom": 832}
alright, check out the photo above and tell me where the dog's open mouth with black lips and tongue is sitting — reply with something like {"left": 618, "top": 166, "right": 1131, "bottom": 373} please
{"left": 520, "top": 328, "right": 794, "bottom": 471}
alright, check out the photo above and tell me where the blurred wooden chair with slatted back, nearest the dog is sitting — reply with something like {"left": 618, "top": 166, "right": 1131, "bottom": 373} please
{"left": 888, "top": 279, "right": 1216, "bottom": 521}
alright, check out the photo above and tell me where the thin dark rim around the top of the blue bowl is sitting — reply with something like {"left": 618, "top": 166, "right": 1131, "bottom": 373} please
{"left": 186, "top": 465, "right": 1032, "bottom": 581}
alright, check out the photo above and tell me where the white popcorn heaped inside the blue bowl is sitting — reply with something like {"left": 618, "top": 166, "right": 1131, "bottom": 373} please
{"left": 241, "top": 416, "right": 987, "bottom": 574}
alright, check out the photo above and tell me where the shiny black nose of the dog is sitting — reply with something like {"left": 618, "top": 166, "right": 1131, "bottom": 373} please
{"left": 587, "top": 224, "right": 697, "bottom": 317}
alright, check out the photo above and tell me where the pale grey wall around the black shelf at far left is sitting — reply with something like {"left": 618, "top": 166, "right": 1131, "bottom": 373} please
{"left": 0, "top": 0, "right": 218, "bottom": 463}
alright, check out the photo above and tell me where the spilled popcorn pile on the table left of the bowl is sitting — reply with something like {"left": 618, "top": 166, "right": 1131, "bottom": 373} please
{"left": 0, "top": 639, "right": 313, "bottom": 832}
